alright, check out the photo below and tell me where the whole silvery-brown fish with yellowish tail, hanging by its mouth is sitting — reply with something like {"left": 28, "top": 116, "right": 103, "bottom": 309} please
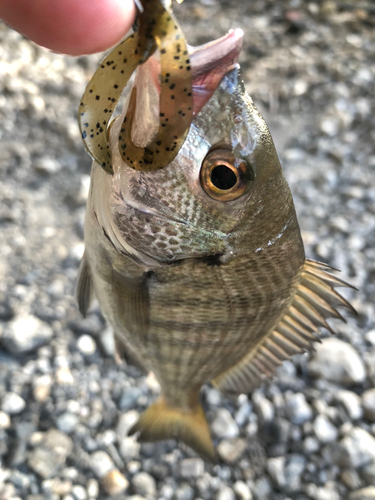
{"left": 77, "top": 2, "right": 354, "bottom": 461}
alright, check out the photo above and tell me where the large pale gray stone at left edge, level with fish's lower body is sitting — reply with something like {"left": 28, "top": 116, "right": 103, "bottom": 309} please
{"left": 1, "top": 315, "right": 53, "bottom": 354}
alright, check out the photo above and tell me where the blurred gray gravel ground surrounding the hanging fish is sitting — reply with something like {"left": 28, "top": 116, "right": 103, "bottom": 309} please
{"left": 0, "top": 0, "right": 375, "bottom": 500}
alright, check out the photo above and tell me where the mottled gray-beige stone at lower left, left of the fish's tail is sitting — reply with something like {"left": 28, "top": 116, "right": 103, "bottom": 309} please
{"left": 28, "top": 429, "right": 73, "bottom": 479}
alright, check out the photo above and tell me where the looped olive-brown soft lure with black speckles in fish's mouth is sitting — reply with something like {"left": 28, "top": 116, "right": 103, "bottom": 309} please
{"left": 78, "top": 0, "right": 193, "bottom": 174}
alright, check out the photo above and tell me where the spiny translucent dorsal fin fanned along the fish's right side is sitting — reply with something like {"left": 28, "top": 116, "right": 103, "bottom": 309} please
{"left": 213, "top": 259, "right": 356, "bottom": 394}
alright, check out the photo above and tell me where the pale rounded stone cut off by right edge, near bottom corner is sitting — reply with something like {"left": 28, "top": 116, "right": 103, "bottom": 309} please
{"left": 334, "top": 427, "right": 375, "bottom": 468}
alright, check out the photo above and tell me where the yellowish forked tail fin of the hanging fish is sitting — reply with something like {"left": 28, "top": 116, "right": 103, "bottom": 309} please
{"left": 129, "top": 397, "right": 216, "bottom": 462}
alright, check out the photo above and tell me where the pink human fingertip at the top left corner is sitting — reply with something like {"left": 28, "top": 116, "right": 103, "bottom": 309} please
{"left": 0, "top": 0, "right": 136, "bottom": 55}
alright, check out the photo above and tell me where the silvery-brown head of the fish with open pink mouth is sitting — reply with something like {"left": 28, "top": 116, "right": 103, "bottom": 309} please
{"left": 108, "top": 30, "right": 298, "bottom": 263}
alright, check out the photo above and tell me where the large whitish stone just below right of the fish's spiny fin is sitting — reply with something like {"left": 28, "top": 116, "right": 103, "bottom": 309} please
{"left": 308, "top": 337, "right": 366, "bottom": 385}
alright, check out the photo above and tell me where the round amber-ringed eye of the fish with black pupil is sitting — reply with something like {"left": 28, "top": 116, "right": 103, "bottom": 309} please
{"left": 200, "top": 149, "right": 254, "bottom": 201}
